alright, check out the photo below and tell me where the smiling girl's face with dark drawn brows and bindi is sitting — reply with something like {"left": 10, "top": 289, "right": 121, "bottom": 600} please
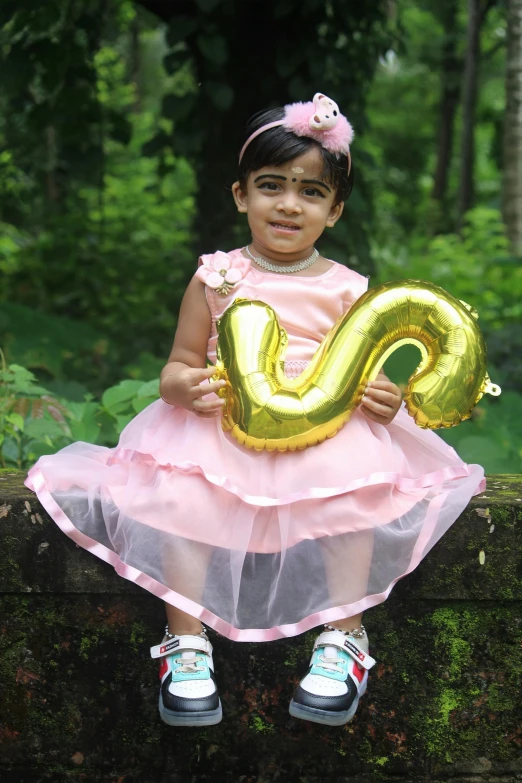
{"left": 232, "top": 147, "right": 344, "bottom": 262}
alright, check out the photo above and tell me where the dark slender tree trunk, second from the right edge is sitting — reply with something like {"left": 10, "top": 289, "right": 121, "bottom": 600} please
{"left": 457, "top": 0, "right": 483, "bottom": 229}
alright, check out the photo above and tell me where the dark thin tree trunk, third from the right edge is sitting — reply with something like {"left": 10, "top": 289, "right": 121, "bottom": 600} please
{"left": 432, "top": 0, "right": 461, "bottom": 202}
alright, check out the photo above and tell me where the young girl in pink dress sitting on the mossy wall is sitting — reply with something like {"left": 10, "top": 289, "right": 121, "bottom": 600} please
{"left": 27, "top": 94, "right": 484, "bottom": 726}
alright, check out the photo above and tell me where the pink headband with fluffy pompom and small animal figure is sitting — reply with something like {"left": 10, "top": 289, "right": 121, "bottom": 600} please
{"left": 239, "top": 92, "right": 353, "bottom": 174}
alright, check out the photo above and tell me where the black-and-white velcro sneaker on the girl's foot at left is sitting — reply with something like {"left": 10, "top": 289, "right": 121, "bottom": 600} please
{"left": 150, "top": 633, "right": 223, "bottom": 726}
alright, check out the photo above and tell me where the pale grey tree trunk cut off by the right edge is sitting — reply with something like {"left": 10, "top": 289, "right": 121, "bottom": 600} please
{"left": 502, "top": 0, "right": 522, "bottom": 255}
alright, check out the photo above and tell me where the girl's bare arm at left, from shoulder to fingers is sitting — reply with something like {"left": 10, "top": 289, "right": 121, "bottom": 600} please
{"left": 160, "top": 277, "right": 225, "bottom": 418}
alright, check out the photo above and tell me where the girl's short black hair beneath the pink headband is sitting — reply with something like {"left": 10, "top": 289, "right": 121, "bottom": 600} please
{"left": 239, "top": 107, "right": 353, "bottom": 203}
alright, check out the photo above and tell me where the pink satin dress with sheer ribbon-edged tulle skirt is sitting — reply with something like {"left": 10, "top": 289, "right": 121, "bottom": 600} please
{"left": 26, "top": 250, "right": 484, "bottom": 641}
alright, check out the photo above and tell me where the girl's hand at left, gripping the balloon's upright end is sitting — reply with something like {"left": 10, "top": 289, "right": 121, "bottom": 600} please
{"left": 161, "top": 365, "right": 225, "bottom": 419}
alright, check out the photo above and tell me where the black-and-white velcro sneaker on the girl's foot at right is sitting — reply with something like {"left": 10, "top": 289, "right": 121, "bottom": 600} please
{"left": 290, "top": 631, "right": 375, "bottom": 726}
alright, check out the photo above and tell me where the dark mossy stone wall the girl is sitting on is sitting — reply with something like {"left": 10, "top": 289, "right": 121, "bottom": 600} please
{"left": 0, "top": 472, "right": 522, "bottom": 783}
